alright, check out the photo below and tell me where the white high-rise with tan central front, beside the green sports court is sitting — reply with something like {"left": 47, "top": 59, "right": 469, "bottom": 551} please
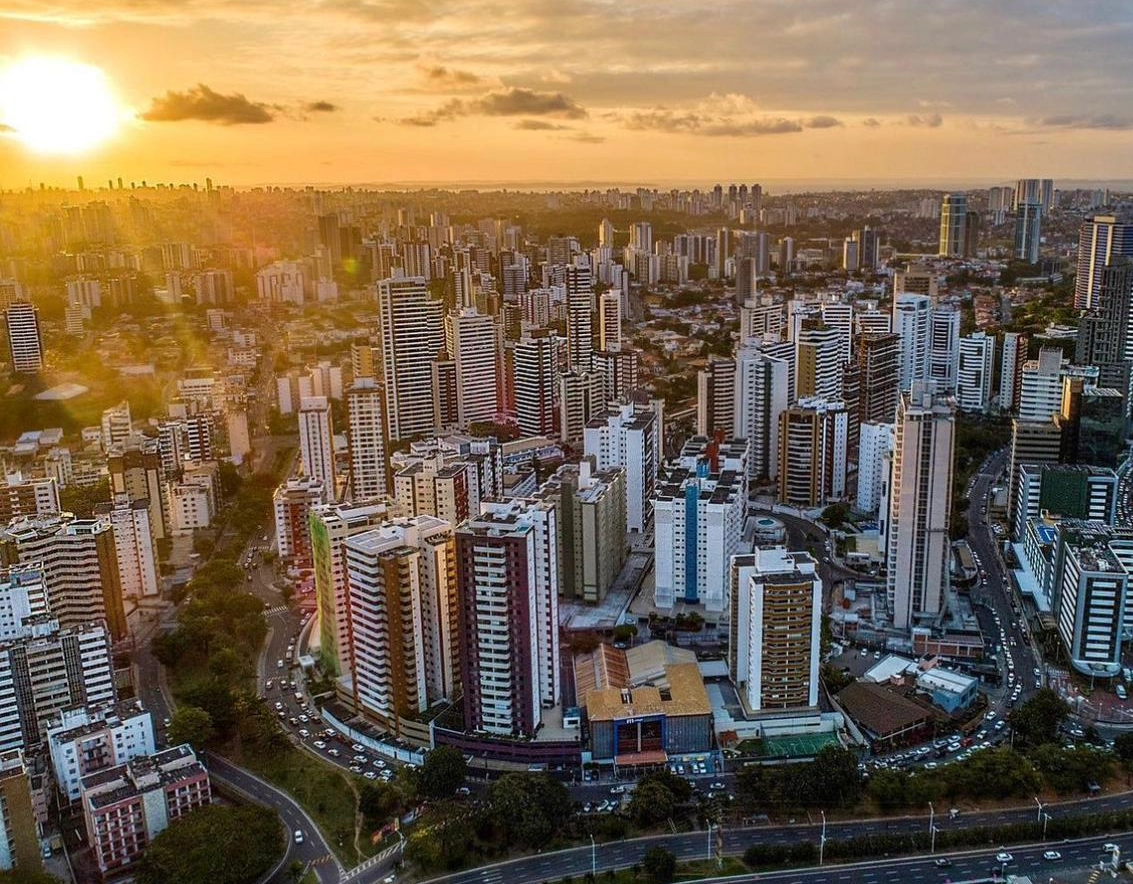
{"left": 727, "top": 546, "right": 823, "bottom": 712}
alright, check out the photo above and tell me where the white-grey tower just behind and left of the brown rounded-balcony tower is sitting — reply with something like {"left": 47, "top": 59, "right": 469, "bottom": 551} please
{"left": 734, "top": 341, "right": 793, "bottom": 482}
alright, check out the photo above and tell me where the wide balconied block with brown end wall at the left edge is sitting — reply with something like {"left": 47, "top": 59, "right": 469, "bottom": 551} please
{"left": 0, "top": 515, "right": 128, "bottom": 641}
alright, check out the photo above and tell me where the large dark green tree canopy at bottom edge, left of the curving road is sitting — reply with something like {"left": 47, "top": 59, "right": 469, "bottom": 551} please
{"left": 136, "top": 805, "right": 284, "bottom": 884}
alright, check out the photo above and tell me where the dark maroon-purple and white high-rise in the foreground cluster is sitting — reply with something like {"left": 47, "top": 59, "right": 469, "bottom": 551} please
{"left": 457, "top": 500, "right": 560, "bottom": 737}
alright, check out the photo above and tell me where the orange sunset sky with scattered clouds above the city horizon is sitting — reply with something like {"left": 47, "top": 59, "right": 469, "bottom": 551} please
{"left": 0, "top": 0, "right": 1133, "bottom": 187}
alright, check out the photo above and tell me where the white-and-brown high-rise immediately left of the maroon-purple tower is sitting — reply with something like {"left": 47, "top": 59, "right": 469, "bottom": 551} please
{"left": 343, "top": 516, "right": 458, "bottom": 733}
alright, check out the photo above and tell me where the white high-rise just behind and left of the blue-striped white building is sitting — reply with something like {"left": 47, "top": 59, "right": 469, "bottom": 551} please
{"left": 583, "top": 401, "right": 664, "bottom": 533}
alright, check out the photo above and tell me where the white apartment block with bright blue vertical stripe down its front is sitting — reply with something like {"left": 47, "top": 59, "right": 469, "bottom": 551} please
{"left": 653, "top": 437, "right": 748, "bottom": 613}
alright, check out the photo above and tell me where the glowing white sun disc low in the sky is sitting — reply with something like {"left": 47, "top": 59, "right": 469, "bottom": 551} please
{"left": 0, "top": 57, "right": 125, "bottom": 154}
